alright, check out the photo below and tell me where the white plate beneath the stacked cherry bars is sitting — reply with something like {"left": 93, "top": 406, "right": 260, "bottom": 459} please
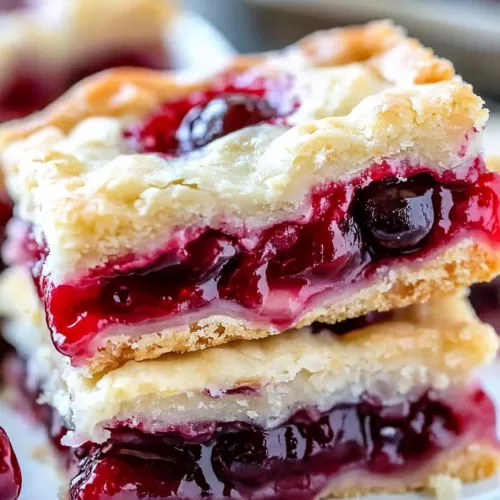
{"left": 0, "top": 362, "right": 500, "bottom": 500}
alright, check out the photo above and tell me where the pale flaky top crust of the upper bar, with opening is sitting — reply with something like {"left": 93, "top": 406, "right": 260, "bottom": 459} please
{"left": 0, "top": 23, "right": 487, "bottom": 279}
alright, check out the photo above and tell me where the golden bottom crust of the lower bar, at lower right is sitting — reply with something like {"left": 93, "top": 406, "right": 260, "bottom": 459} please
{"left": 318, "top": 442, "right": 500, "bottom": 500}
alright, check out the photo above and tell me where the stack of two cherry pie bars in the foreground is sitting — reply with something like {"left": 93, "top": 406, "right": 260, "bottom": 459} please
{"left": 0, "top": 23, "right": 500, "bottom": 500}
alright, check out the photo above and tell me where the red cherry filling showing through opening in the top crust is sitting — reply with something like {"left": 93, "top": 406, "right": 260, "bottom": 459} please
{"left": 125, "top": 74, "right": 298, "bottom": 157}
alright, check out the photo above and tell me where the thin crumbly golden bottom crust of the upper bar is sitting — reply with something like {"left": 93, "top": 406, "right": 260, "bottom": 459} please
{"left": 84, "top": 241, "right": 500, "bottom": 373}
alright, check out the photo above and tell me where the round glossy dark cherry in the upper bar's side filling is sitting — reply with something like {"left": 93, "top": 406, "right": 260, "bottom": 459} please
{"left": 357, "top": 174, "right": 435, "bottom": 252}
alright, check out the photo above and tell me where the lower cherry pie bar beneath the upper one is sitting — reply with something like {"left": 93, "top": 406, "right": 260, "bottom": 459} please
{"left": 0, "top": 268, "right": 500, "bottom": 500}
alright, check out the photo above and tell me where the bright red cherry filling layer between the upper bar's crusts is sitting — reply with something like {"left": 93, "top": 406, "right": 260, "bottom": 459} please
{"left": 18, "top": 153, "right": 500, "bottom": 364}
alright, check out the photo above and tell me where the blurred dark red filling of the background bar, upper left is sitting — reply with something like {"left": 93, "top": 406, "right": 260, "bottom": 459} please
{"left": 0, "top": 46, "right": 169, "bottom": 122}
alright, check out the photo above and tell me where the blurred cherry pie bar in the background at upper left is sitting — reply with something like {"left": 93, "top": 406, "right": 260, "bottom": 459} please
{"left": 0, "top": 0, "right": 174, "bottom": 121}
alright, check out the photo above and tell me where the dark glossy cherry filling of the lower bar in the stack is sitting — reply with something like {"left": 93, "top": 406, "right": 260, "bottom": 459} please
{"left": 69, "top": 390, "right": 495, "bottom": 500}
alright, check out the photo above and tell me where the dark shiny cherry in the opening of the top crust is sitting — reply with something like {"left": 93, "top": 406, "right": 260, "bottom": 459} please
{"left": 176, "top": 94, "right": 276, "bottom": 152}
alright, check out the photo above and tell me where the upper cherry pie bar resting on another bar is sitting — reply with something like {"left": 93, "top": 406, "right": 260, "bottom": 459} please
{"left": 0, "top": 23, "right": 500, "bottom": 373}
